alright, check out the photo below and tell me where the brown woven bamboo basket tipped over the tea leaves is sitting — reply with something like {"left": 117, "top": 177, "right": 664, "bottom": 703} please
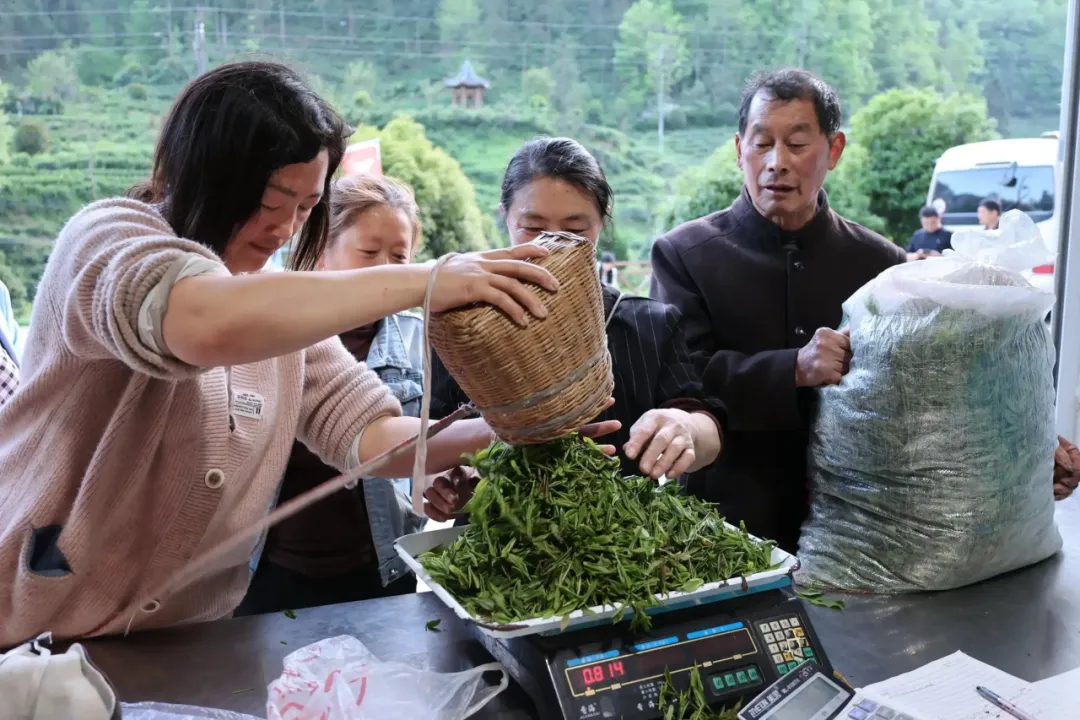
{"left": 429, "top": 232, "right": 615, "bottom": 445}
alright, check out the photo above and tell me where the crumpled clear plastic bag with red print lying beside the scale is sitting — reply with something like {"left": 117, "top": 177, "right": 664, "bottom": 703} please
{"left": 267, "top": 635, "right": 510, "bottom": 720}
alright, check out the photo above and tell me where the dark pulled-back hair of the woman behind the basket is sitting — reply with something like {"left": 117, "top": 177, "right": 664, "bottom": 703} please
{"left": 499, "top": 137, "right": 615, "bottom": 223}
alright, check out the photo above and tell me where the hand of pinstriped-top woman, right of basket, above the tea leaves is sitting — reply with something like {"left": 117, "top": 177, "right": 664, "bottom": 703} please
{"left": 623, "top": 408, "right": 720, "bottom": 479}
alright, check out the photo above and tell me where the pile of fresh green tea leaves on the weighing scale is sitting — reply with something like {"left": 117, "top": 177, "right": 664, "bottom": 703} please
{"left": 420, "top": 436, "right": 772, "bottom": 628}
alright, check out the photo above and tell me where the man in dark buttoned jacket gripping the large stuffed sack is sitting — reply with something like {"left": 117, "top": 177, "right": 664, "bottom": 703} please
{"left": 652, "top": 70, "right": 906, "bottom": 551}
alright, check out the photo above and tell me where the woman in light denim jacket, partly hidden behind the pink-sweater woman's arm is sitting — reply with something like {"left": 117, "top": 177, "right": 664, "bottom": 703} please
{"left": 237, "top": 176, "right": 424, "bottom": 615}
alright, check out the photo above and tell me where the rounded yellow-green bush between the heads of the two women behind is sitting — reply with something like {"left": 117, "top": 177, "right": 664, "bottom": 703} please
{"left": 355, "top": 116, "right": 490, "bottom": 258}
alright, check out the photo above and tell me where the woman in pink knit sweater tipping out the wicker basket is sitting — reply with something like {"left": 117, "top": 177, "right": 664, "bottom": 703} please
{"left": 0, "top": 63, "right": 604, "bottom": 648}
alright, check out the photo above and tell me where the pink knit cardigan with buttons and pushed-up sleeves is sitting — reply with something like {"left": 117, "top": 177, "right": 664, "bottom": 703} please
{"left": 0, "top": 199, "right": 401, "bottom": 648}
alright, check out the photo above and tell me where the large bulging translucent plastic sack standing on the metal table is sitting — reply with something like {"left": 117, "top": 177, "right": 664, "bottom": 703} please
{"left": 796, "top": 212, "right": 1062, "bottom": 593}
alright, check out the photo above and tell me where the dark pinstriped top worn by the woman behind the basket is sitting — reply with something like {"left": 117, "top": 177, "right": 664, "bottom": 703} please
{"left": 431, "top": 285, "right": 727, "bottom": 475}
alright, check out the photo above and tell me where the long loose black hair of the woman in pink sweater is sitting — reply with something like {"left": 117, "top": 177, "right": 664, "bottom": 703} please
{"left": 129, "top": 60, "right": 352, "bottom": 270}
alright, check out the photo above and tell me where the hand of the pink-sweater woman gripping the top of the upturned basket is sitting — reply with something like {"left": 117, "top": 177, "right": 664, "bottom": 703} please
{"left": 431, "top": 243, "right": 558, "bottom": 326}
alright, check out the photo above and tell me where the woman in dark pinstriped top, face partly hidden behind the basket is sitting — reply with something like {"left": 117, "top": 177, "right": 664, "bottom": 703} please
{"left": 427, "top": 137, "right": 725, "bottom": 520}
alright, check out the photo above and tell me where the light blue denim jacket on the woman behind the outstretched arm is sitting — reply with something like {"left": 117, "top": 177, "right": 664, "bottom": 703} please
{"left": 361, "top": 313, "right": 427, "bottom": 585}
